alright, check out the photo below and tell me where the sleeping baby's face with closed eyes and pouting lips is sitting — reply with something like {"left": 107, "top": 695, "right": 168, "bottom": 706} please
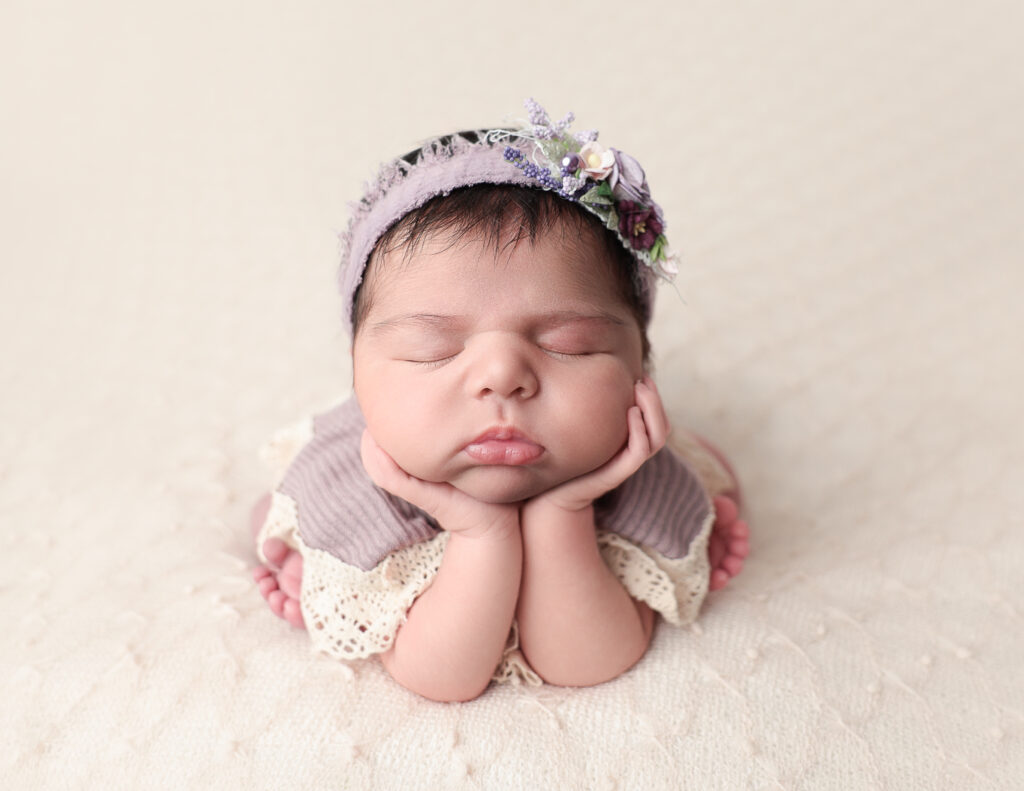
{"left": 352, "top": 230, "right": 643, "bottom": 503}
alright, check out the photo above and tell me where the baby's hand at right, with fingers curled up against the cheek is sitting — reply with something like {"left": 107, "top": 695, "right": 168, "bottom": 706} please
{"left": 535, "top": 376, "right": 672, "bottom": 511}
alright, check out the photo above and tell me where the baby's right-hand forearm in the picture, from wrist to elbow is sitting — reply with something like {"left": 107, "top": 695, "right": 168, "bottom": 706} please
{"left": 516, "top": 500, "right": 653, "bottom": 686}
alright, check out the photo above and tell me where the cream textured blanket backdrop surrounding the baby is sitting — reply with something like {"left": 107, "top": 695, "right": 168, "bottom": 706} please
{"left": 0, "top": 0, "right": 1024, "bottom": 789}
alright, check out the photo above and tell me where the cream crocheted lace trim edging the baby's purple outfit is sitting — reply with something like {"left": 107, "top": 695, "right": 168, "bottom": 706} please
{"left": 257, "top": 407, "right": 733, "bottom": 685}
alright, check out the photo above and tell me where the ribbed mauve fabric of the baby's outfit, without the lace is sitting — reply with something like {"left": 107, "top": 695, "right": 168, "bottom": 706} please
{"left": 278, "top": 397, "right": 712, "bottom": 571}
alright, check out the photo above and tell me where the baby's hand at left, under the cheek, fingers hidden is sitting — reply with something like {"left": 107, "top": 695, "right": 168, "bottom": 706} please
{"left": 359, "top": 428, "right": 519, "bottom": 538}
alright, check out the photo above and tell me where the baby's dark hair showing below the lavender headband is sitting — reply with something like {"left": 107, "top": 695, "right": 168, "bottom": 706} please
{"left": 352, "top": 184, "right": 650, "bottom": 363}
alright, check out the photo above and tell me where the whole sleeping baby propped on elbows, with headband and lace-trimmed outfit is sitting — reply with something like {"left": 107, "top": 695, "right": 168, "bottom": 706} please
{"left": 253, "top": 103, "right": 749, "bottom": 701}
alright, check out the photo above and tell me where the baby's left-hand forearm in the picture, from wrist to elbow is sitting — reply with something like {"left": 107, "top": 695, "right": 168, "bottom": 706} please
{"left": 381, "top": 522, "right": 522, "bottom": 701}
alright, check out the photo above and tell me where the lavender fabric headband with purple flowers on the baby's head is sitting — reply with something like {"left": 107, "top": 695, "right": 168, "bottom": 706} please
{"left": 338, "top": 99, "right": 678, "bottom": 331}
